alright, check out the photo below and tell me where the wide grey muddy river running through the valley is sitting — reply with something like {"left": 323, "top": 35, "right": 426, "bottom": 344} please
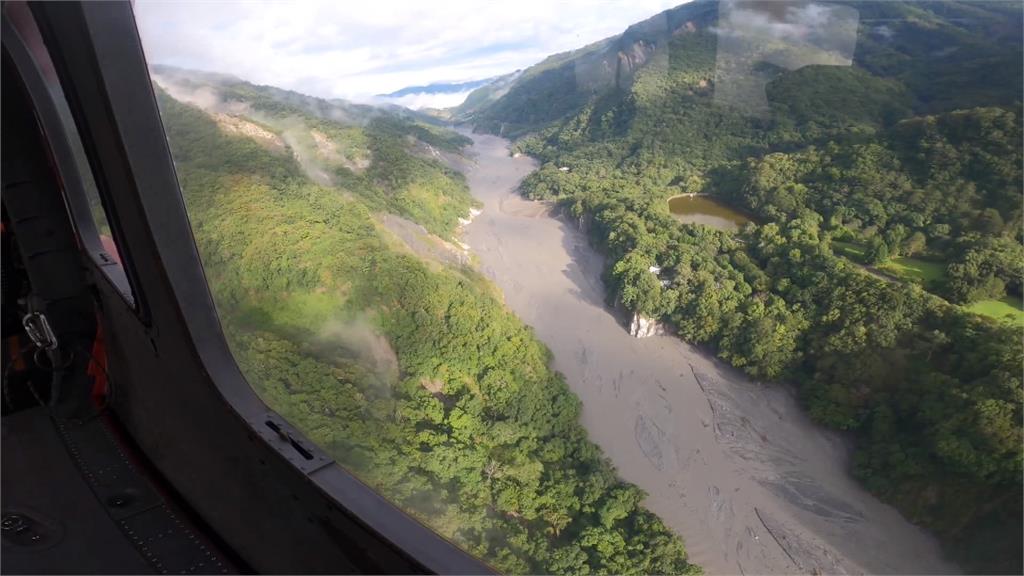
{"left": 464, "top": 131, "right": 955, "bottom": 574}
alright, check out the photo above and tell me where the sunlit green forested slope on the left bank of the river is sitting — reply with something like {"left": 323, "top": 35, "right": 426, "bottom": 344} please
{"left": 153, "top": 86, "right": 699, "bottom": 574}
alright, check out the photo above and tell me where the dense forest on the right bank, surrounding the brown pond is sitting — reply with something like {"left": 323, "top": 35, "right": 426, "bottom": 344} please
{"left": 457, "top": 1, "right": 1024, "bottom": 573}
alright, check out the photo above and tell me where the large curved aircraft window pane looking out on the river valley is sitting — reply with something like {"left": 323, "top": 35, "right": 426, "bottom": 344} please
{"left": 134, "top": 0, "right": 1024, "bottom": 574}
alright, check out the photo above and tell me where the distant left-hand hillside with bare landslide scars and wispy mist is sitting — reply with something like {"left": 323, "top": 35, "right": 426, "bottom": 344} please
{"left": 155, "top": 69, "right": 474, "bottom": 239}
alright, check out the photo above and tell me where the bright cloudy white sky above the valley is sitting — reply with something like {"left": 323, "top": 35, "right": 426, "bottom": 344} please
{"left": 134, "top": 0, "right": 683, "bottom": 108}
